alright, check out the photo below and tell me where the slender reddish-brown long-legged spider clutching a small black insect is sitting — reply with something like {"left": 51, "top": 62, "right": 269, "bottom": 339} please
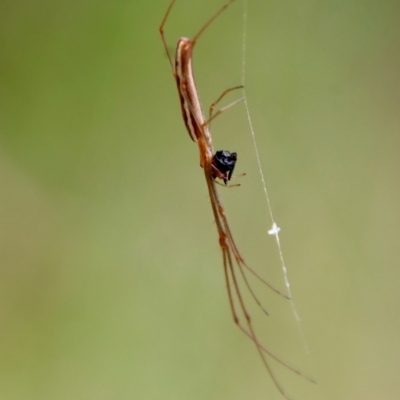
{"left": 159, "top": 0, "right": 315, "bottom": 399}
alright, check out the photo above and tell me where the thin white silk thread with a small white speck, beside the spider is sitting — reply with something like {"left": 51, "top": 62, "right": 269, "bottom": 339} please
{"left": 242, "top": 0, "right": 310, "bottom": 354}
